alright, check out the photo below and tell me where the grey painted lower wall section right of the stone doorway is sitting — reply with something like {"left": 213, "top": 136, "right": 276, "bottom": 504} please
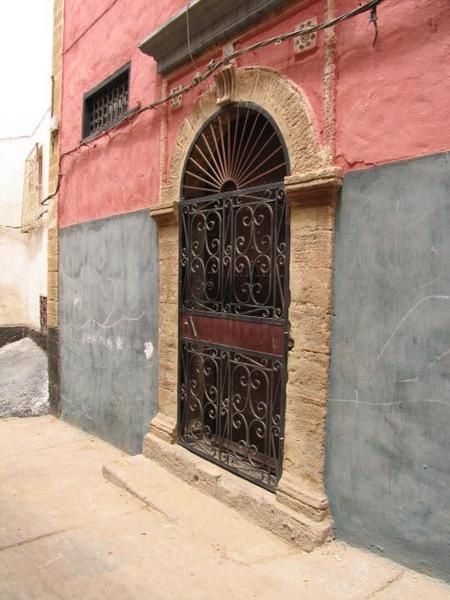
{"left": 327, "top": 153, "right": 450, "bottom": 578}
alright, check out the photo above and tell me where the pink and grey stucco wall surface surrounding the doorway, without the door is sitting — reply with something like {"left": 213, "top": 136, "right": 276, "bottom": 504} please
{"left": 58, "top": 0, "right": 450, "bottom": 575}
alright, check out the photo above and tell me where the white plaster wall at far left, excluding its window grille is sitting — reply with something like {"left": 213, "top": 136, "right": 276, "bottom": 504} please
{"left": 0, "top": 0, "right": 53, "bottom": 329}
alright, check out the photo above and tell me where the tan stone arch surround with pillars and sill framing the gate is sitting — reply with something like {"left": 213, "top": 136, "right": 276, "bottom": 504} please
{"left": 143, "top": 67, "right": 342, "bottom": 549}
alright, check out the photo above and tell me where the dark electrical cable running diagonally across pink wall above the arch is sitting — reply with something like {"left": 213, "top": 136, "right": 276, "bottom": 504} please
{"left": 41, "top": 0, "right": 383, "bottom": 204}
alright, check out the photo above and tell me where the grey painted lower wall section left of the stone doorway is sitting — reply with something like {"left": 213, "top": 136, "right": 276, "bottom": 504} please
{"left": 60, "top": 211, "right": 158, "bottom": 454}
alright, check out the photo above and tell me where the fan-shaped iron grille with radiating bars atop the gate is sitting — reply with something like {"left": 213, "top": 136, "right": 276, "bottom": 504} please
{"left": 182, "top": 105, "right": 288, "bottom": 198}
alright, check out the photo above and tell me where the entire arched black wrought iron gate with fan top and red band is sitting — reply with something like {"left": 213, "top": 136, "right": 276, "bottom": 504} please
{"left": 178, "top": 105, "right": 289, "bottom": 489}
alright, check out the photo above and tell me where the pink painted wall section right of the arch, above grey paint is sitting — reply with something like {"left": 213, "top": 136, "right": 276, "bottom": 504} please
{"left": 336, "top": 0, "right": 450, "bottom": 169}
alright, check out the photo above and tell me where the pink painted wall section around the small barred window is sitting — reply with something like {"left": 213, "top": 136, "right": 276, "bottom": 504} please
{"left": 59, "top": 0, "right": 185, "bottom": 227}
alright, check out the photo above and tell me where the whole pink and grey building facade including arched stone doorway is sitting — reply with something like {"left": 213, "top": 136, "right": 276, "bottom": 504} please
{"left": 49, "top": 0, "right": 450, "bottom": 576}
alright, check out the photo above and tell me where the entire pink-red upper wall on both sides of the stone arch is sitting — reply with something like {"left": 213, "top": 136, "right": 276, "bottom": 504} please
{"left": 59, "top": 0, "right": 450, "bottom": 227}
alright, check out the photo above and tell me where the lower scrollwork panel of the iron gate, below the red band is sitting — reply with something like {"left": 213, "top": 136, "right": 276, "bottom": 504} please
{"left": 179, "top": 340, "right": 285, "bottom": 489}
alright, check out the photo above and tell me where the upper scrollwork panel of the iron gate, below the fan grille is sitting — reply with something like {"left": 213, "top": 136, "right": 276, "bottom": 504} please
{"left": 180, "top": 185, "right": 288, "bottom": 320}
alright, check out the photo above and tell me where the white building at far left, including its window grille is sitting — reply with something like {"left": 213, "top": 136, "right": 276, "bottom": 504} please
{"left": 0, "top": 0, "right": 52, "bottom": 345}
